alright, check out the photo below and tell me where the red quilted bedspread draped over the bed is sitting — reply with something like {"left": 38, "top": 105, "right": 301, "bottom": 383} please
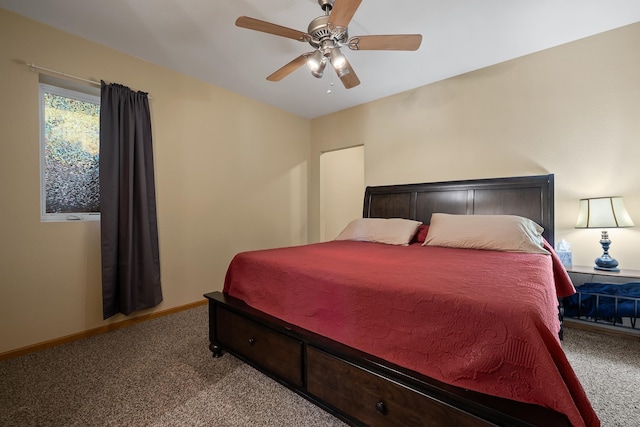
{"left": 224, "top": 241, "right": 600, "bottom": 426}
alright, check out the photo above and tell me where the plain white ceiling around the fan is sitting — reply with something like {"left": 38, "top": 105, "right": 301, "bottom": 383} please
{"left": 0, "top": 0, "right": 640, "bottom": 118}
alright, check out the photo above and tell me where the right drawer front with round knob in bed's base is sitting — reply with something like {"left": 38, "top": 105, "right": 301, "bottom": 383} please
{"left": 307, "top": 346, "right": 493, "bottom": 427}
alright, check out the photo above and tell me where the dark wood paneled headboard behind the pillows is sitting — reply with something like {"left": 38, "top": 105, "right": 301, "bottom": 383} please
{"left": 363, "top": 174, "right": 554, "bottom": 245}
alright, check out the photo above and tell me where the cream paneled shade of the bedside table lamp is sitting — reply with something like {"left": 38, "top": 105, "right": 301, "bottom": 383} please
{"left": 576, "top": 197, "right": 633, "bottom": 228}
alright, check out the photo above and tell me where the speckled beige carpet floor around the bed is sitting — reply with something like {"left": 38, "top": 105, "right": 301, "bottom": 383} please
{"left": 0, "top": 306, "right": 640, "bottom": 427}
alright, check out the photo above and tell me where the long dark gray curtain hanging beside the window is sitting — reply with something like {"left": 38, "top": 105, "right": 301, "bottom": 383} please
{"left": 100, "top": 82, "right": 162, "bottom": 319}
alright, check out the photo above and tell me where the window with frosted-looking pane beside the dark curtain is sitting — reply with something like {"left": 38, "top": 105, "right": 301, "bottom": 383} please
{"left": 40, "top": 76, "right": 100, "bottom": 222}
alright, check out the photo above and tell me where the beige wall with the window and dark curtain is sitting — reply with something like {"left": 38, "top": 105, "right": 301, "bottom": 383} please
{"left": 0, "top": 9, "right": 310, "bottom": 353}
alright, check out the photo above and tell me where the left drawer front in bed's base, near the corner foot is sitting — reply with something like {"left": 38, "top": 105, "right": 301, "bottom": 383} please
{"left": 216, "top": 306, "right": 302, "bottom": 387}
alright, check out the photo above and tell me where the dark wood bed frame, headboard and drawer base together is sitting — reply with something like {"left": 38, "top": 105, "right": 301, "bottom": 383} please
{"left": 205, "top": 175, "right": 568, "bottom": 427}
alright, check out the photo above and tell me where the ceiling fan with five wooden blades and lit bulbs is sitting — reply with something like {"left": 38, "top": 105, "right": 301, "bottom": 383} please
{"left": 236, "top": 0, "right": 422, "bottom": 89}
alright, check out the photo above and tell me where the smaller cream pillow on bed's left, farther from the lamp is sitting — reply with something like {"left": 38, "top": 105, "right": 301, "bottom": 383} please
{"left": 336, "top": 218, "right": 422, "bottom": 246}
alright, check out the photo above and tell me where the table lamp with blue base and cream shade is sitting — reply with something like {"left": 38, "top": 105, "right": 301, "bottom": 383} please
{"left": 576, "top": 197, "right": 633, "bottom": 271}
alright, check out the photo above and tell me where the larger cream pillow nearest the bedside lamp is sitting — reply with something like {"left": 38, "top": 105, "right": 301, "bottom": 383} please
{"left": 422, "top": 213, "right": 549, "bottom": 255}
